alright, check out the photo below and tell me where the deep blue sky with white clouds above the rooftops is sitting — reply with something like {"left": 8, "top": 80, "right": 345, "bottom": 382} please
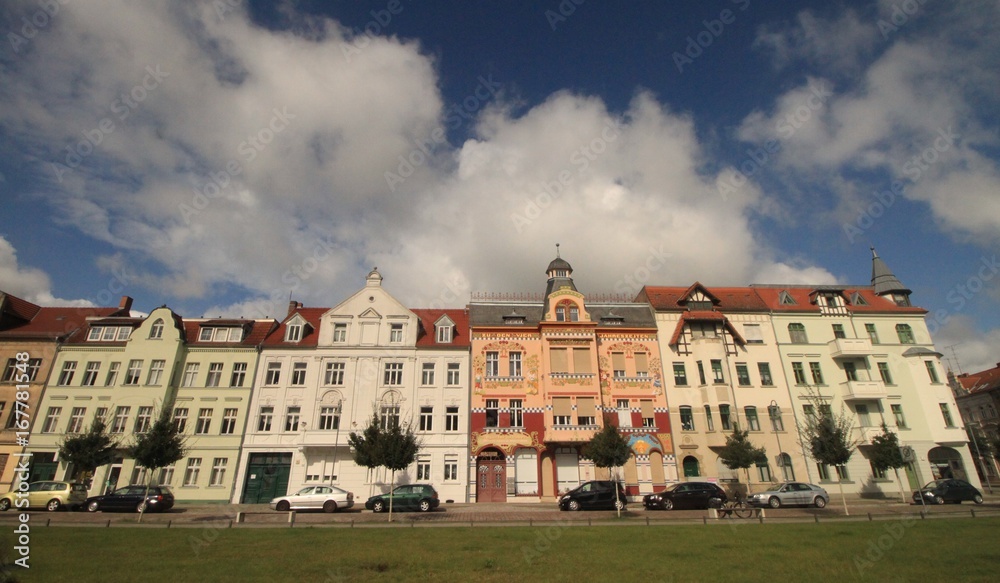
{"left": 0, "top": 0, "right": 1000, "bottom": 370}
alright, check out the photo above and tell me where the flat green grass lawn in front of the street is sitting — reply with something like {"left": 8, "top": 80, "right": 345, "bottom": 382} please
{"left": 0, "top": 518, "right": 1000, "bottom": 583}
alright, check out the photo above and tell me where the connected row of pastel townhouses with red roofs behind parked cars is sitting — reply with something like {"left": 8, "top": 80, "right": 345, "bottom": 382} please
{"left": 0, "top": 252, "right": 979, "bottom": 503}
